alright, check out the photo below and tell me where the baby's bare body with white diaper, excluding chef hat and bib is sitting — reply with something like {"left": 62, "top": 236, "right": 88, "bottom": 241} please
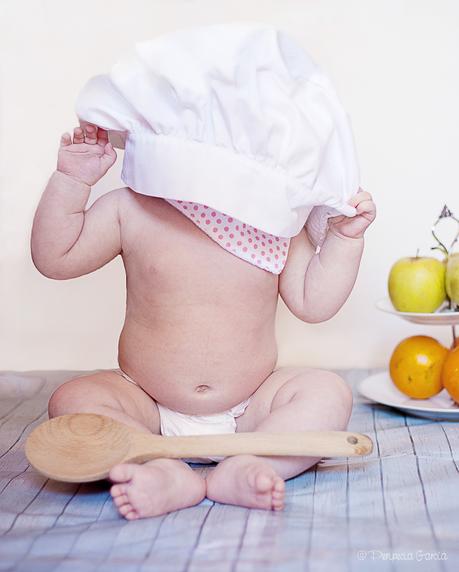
{"left": 31, "top": 124, "right": 376, "bottom": 519}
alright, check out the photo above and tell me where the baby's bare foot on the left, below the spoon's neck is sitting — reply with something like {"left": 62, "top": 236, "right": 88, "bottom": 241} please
{"left": 110, "top": 459, "right": 206, "bottom": 520}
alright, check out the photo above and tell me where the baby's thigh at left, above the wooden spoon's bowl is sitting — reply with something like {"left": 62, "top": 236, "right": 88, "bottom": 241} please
{"left": 48, "top": 370, "right": 160, "bottom": 433}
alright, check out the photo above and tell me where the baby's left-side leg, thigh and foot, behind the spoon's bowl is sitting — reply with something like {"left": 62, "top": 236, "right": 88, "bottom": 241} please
{"left": 48, "top": 371, "right": 206, "bottom": 519}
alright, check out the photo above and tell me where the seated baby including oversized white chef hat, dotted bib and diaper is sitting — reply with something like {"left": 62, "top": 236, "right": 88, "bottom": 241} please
{"left": 31, "top": 24, "right": 376, "bottom": 519}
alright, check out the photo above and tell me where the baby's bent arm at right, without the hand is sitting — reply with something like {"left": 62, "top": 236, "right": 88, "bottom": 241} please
{"left": 279, "top": 228, "right": 364, "bottom": 323}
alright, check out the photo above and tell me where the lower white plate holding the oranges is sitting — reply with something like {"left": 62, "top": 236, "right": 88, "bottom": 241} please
{"left": 358, "top": 370, "right": 459, "bottom": 421}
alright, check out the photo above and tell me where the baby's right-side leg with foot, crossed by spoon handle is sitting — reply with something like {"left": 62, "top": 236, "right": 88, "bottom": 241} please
{"left": 207, "top": 368, "right": 352, "bottom": 510}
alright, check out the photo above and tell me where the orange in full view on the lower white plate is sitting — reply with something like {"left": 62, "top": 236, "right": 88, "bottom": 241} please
{"left": 389, "top": 336, "right": 448, "bottom": 399}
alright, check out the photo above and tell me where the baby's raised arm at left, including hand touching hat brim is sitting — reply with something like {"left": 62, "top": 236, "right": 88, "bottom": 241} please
{"left": 31, "top": 126, "right": 121, "bottom": 280}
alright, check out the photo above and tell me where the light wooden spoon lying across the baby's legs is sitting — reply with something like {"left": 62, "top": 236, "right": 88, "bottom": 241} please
{"left": 25, "top": 413, "right": 373, "bottom": 483}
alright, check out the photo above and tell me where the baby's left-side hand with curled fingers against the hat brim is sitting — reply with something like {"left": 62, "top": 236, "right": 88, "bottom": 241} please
{"left": 57, "top": 123, "right": 116, "bottom": 186}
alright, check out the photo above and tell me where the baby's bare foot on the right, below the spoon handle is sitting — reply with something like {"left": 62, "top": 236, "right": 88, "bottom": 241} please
{"left": 207, "top": 455, "right": 285, "bottom": 510}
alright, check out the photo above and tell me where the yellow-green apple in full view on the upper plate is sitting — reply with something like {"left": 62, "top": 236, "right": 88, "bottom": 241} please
{"left": 388, "top": 256, "right": 446, "bottom": 313}
